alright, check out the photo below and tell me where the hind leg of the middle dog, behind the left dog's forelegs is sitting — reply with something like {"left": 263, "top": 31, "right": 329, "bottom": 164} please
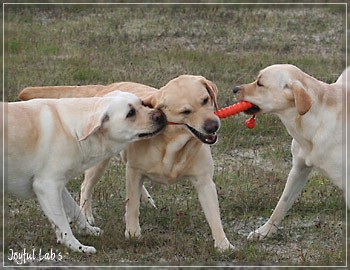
{"left": 80, "top": 159, "right": 110, "bottom": 225}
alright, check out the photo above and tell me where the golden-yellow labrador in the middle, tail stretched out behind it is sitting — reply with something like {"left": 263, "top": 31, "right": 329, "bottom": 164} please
{"left": 19, "top": 75, "right": 233, "bottom": 250}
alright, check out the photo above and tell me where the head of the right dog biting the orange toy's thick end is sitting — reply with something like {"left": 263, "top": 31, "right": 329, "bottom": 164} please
{"left": 233, "top": 64, "right": 312, "bottom": 115}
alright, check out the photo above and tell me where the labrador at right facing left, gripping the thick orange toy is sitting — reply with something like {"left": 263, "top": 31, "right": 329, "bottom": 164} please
{"left": 233, "top": 64, "right": 350, "bottom": 239}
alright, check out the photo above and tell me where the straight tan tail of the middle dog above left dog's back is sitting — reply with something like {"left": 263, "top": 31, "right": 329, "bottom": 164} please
{"left": 18, "top": 85, "right": 105, "bottom": 100}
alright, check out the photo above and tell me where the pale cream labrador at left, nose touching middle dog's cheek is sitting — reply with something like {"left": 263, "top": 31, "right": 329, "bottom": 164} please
{"left": 2, "top": 91, "right": 166, "bottom": 253}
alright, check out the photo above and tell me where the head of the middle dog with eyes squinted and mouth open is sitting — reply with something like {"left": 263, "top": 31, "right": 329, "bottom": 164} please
{"left": 144, "top": 75, "right": 220, "bottom": 144}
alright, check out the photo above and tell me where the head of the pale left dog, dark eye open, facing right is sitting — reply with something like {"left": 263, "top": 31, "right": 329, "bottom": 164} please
{"left": 79, "top": 91, "right": 167, "bottom": 143}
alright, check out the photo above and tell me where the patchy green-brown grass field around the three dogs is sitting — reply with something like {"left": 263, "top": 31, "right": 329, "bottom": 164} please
{"left": 3, "top": 4, "right": 346, "bottom": 267}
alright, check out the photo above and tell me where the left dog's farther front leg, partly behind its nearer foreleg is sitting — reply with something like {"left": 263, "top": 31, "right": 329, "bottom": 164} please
{"left": 62, "top": 188, "right": 102, "bottom": 236}
